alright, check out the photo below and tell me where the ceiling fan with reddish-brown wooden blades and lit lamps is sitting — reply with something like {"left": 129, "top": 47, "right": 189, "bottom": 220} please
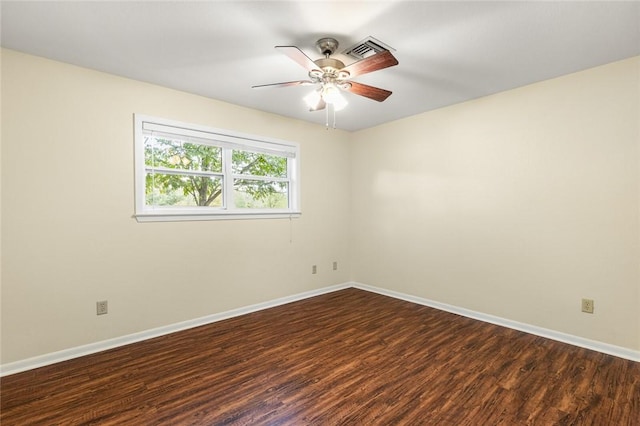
{"left": 252, "top": 37, "right": 398, "bottom": 111}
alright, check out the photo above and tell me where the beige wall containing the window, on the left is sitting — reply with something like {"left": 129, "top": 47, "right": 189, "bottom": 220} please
{"left": 2, "top": 50, "right": 349, "bottom": 363}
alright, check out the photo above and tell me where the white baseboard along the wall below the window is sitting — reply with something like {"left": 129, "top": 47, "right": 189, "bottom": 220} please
{"left": 0, "top": 283, "right": 352, "bottom": 377}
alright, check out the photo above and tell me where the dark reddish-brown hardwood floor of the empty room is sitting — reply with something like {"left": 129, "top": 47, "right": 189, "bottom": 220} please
{"left": 0, "top": 289, "right": 640, "bottom": 426}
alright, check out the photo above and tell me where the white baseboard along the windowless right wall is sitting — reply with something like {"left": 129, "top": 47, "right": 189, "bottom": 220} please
{"left": 351, "top": 283, "right": 640, "bottom": 362}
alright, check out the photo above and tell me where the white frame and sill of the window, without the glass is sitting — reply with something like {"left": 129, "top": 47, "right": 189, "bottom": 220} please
{"left": 134, "top": 114, "right": 301, "bottom": 222}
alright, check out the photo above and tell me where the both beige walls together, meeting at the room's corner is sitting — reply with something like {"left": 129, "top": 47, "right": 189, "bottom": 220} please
{"left": 1, "top": 50, "right": 640, "bottom": 364}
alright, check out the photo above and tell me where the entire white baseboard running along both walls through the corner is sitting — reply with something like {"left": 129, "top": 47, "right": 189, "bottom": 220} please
{"left": 0, "top": 282, "right": 640, "bottom": 377}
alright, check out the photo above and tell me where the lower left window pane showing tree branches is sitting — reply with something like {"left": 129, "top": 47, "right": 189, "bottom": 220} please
{"left": 145, "top": 173, "right": 222, "bottom": 207}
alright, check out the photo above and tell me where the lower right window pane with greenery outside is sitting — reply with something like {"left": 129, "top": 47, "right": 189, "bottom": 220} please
{"left": 233, "top": 179, "right": 289, "bottom": 209}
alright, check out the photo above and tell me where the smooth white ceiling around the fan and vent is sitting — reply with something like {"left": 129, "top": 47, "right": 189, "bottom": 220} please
{"left": 1, "top": 1, "right": 640, "bottom": 131}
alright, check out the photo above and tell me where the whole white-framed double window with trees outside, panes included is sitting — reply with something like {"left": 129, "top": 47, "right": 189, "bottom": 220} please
{"left": 135, "top": 115, "right": 300, "bottom": 221}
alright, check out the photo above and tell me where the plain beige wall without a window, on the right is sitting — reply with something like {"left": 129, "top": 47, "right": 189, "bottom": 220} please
{"left": 351, "top": 57, "right": 640, "bottom": 350}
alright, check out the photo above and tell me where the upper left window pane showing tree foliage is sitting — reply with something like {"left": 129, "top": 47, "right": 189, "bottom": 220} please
{"left": 144, "top": 137, "right": 222, "bottom": 172}
